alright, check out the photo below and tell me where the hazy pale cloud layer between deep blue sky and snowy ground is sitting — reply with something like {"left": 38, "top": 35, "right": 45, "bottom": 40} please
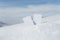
{"left": 0, "top": 4, "right": 60, "bottom": 23}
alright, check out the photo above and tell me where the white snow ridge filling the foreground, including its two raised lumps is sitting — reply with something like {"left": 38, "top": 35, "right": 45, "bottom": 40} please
{"left": 0, "top": 14, "right": 60, "bottom": 40}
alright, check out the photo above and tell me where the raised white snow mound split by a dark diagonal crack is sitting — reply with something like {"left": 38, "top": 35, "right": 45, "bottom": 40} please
{"left": 23, "top": 14, "right": 43, "bottom": 25}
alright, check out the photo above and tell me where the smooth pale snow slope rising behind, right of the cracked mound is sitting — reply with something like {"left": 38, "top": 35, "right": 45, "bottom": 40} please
{"left": 44, "top": 15, "right": 60, "bottom": 24}
